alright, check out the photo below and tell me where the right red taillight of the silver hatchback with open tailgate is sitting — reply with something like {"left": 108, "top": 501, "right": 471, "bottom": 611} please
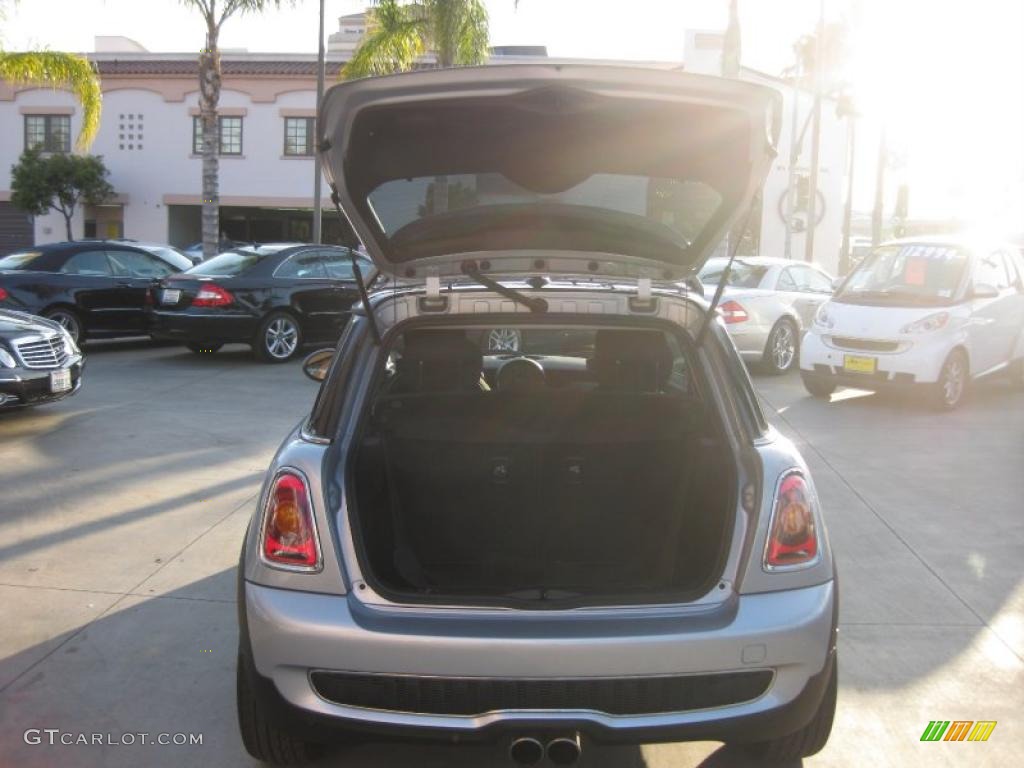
{"left": 764, "top": 471, "right": 818, "bottom": 570}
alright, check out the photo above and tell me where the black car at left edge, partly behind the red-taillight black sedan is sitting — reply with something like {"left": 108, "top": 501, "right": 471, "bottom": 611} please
{"left": 0, "top": 240, "right": 191, "bottom": 343}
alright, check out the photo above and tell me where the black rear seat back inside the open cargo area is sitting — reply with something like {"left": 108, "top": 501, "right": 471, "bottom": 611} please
{"left": 375, "top": 391, "right": 702, "bottom": 589}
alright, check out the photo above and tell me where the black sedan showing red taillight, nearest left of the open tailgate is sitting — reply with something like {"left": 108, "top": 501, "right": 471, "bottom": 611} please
{"left": 150, "top": 244, "right": 376, "bottom": 362}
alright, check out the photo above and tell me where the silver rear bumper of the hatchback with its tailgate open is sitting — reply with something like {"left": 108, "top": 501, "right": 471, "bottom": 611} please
{"left": 240, "top": 582, "right": 837, "bottom": 743}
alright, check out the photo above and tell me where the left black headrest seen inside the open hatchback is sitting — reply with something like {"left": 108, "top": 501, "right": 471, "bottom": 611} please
{"left": 397, "top": 330, "right": 483, "bottom": 392}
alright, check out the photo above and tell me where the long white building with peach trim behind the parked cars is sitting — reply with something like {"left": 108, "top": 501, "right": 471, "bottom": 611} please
{"left": 0, "top": 24, "right": 847, "bottom": 270}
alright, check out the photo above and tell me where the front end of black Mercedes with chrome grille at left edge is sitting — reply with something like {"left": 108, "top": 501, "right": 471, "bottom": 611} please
{"left": 0, "top": 309, "right": 85, "bottom": 411}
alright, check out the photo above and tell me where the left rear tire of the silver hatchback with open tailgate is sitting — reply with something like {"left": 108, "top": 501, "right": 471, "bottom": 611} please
{"left": 236, "top": 650, "right": 318, "bottom": 766}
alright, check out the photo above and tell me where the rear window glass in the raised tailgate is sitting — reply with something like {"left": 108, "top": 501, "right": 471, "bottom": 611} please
{"left": 368, "top": 171, "right": 722, "bottom": 261}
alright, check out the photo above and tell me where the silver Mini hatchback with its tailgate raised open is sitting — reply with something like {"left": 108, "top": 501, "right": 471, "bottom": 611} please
{"left": 238, "top": 65, "right": 838, "bottom": 765}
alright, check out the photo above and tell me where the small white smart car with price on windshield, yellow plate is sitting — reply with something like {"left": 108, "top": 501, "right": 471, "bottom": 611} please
{"left": 800, "top": 238, "right": 1024, "bottom": 410}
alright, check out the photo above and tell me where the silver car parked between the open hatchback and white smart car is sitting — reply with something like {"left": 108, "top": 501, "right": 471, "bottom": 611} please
{"left": 700, "top": 256, "right": 835, "bottom": 374}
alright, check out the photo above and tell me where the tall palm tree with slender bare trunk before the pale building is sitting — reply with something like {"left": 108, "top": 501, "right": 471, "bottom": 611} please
{"left": 181, "top": 0, "right": 292, "bottom": 258}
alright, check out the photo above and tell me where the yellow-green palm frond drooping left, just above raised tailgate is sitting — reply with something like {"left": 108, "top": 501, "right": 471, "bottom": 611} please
{"left": 341, "top": 0, "right": 428, "bottom": 80}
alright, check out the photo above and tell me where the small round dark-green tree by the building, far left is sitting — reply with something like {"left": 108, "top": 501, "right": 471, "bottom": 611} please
{"left": 10, "top": 147, "right": 114, "bottom": 240}
